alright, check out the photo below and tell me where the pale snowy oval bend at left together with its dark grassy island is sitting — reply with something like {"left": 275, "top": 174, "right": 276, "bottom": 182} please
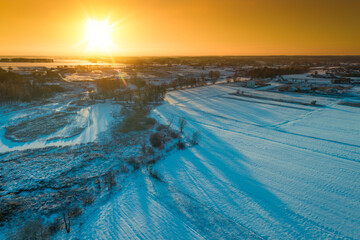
{"left": 0, "top": 102, "right": 121, "bottom": 153}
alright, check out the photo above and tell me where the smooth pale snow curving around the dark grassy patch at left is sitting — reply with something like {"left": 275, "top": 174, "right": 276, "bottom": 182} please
{"left": 0, "top": 103, "right": 121, "bottom": 153}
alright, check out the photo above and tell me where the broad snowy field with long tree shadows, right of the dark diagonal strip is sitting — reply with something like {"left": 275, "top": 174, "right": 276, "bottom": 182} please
{"left": 155, "top": 84, "right": 360, "bottom": 239}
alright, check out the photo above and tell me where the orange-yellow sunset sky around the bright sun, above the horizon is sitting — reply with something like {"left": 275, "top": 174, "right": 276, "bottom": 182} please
{"left": 0, "top": 0, "right": 360, "bottom": 56}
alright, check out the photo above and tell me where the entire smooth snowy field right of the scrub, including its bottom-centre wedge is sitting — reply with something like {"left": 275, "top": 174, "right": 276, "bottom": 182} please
{"left": 59, "top": 85, "right": 360, "bottom": 239}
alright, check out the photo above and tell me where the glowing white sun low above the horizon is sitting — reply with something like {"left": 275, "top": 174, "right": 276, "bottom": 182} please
{"left": 85, "top": 19, "right": 114, "bottom": 53}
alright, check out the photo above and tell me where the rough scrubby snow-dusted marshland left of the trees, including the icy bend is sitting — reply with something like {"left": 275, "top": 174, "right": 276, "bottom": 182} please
{"left": 0, "top": 89, "right": 138, "bottom": 239}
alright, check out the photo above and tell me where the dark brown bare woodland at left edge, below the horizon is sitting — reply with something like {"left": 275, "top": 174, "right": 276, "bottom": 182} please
{"left": 0, "top": 68, "right": 64, "bottom": 103}
